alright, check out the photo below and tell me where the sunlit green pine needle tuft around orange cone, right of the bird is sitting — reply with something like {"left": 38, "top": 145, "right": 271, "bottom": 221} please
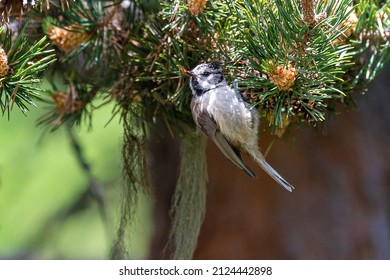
{"left": 222, "top": 0, "right": 351, "bottom": 127}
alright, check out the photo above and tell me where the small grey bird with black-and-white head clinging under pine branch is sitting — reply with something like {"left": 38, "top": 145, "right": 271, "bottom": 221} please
{"left": 187, "top": 62, "right": 294, "bottom": 192}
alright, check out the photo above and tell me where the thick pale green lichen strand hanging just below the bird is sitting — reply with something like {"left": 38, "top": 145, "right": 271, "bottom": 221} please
{"left": 168, "top": 132, "right": 207, "bottom": 260}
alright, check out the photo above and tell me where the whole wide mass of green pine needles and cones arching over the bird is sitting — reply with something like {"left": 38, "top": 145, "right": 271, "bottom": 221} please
{"left": 114, "top": 0, "right": 387, "bottom": 130}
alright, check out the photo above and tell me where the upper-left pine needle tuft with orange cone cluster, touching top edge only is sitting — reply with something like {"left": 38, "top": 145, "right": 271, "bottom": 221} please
{"left": 38, "top": 0, "right": 136, "bottom": 70}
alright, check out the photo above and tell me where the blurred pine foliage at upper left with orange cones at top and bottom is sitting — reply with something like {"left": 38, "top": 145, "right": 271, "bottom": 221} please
{"left": 35, "top": 0, "right": 138, "bottom": 129}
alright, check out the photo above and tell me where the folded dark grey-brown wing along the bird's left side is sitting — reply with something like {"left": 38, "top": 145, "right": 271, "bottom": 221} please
{"left": 191, "top": 99, "right": 256, "bottom": 177}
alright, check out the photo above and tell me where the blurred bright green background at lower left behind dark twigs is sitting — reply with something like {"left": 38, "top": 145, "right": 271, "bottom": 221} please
{"left": 0, "top": 97, "right": 151, "bottom": 259}
